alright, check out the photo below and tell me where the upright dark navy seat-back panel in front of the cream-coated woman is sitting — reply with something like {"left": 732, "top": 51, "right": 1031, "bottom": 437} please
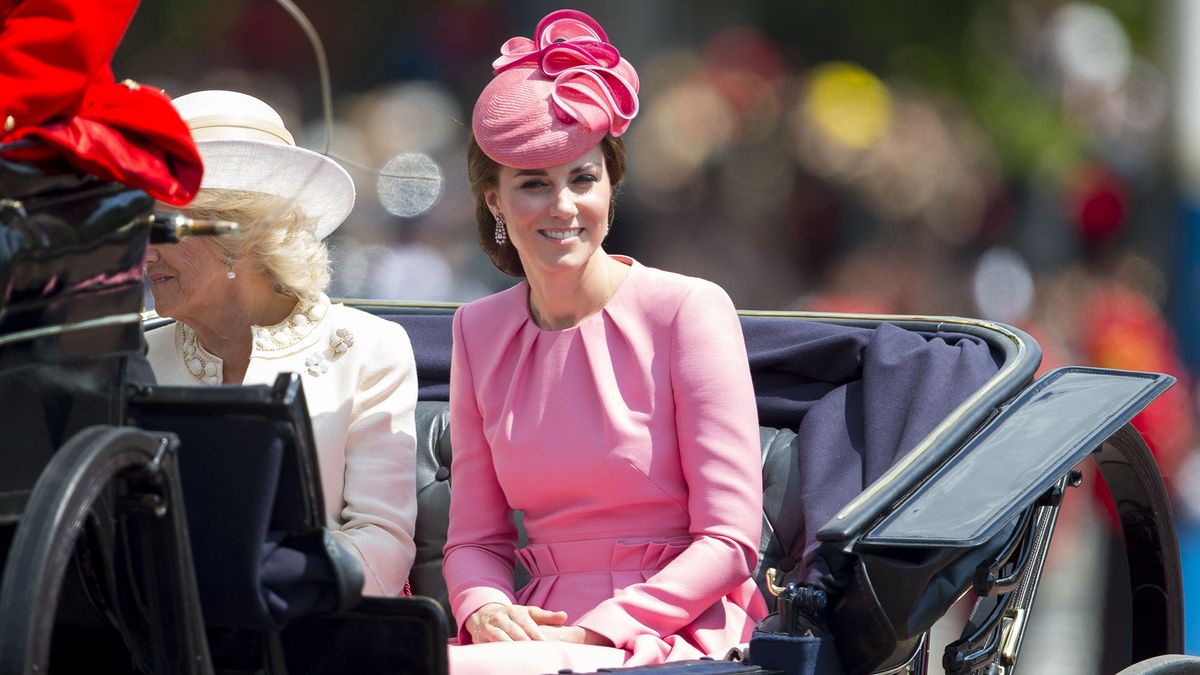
{"left": 130, "top": 374, "right": 362, "bottom": 631}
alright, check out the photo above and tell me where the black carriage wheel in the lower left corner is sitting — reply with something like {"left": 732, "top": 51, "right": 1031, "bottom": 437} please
{"left": 0, "top": 426, "right": 211, "bottom": 674}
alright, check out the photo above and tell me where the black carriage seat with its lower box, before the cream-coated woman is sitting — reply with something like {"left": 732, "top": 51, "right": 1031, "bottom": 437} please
{"left": 130, "top": 374, "right": 446, "bottom": 673}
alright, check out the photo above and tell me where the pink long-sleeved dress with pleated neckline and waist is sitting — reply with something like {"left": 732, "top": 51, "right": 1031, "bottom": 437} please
{"left": 443, "top": 258, "right": 766, "bottom": 674}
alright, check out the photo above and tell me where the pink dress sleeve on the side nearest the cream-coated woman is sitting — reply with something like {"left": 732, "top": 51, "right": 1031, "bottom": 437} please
{"left": 442, "top": 306, "right": 517, "bottom": 644}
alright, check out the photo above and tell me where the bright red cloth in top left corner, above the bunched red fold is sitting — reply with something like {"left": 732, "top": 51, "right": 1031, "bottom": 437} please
{"left": 0, "top": 0, "right": 138, "bottom": 127}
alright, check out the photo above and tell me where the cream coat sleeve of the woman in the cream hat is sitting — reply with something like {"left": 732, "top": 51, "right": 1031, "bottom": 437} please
{"left": 336, "top": 322, "right": 416, "bottom": 596}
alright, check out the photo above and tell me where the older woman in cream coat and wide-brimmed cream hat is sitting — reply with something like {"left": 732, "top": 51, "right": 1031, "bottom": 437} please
{"left": 145, "top": 91, "right": 416, "bottom": 596}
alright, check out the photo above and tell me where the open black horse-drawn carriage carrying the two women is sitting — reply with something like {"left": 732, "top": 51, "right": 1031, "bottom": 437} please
{"left": 0, "top": 165, "right": 1187, "bottom": 674}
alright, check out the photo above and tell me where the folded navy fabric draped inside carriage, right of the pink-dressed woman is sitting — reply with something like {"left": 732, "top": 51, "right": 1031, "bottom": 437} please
{"left": 742, "top": 317, "right": 998, "bottom": 590}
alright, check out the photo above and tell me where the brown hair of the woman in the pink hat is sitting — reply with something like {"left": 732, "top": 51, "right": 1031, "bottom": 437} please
{"left": 467, "top": 135, "right": 625, "bottom": 276}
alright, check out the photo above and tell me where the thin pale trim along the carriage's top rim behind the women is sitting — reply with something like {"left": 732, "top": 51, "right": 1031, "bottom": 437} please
{"left": 334, "top": 299, "right": 1030, "bottom": 520}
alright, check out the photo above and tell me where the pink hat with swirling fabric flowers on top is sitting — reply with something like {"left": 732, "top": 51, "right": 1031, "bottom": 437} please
{"left": 470, "top": 10, "right": 638, "bottom": 168}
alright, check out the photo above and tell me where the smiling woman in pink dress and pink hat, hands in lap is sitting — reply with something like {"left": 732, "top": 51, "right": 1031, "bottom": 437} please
{"left": 443, "top": 10, "right": 766, "bottom": 674}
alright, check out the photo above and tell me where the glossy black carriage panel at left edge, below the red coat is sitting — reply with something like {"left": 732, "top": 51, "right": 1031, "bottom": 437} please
{"left": 0, "top": 165, "right": 154, "bottom": 524}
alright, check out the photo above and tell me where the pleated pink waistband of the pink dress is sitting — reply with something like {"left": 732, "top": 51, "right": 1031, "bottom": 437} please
{"left": 516, "top": 534, "right": 692, "bottom": 577}
